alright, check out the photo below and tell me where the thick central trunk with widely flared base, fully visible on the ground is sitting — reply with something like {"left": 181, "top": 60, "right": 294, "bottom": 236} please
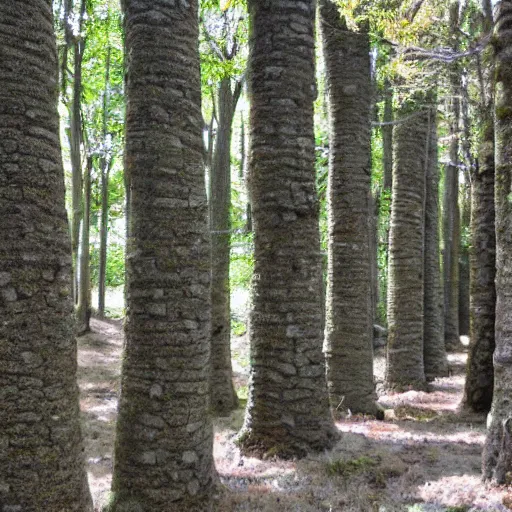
{"left": 239, "top": 0, "right": 336, "bottom": 457}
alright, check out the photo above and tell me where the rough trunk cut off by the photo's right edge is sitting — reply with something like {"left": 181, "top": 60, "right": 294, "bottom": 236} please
{"left": 483, "top": 0, "right": 512, "bottom": 484}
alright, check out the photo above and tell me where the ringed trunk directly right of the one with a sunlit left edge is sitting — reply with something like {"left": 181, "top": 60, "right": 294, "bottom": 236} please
{"left": 386, "top": 105, "right": 429, "bottom": 389}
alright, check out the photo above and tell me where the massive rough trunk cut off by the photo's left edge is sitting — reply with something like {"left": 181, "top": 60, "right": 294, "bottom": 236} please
{"left": 0, "top": 0, "right": 92, "bottom": 512}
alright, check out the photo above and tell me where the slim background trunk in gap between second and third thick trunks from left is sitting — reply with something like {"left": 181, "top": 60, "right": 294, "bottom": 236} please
{"left": 210, "top": 77, "right": 240, "bottom": 414}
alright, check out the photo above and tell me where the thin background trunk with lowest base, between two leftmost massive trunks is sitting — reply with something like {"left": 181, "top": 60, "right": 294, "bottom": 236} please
{"left": 76, "top": 156, "right": 92, "bottom": 334}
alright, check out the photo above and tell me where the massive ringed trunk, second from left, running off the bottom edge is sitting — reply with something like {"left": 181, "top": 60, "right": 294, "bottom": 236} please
{"left": 111, "top": 0, "right": 213, "bottom": 512}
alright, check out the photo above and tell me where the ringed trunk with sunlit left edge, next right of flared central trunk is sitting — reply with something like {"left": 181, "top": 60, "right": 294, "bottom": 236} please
{"left": 320, "top": 0, "right": 377, "bottom": 414}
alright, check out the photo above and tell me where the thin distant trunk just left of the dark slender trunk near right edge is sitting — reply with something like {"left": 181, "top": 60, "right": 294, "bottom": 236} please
{"left": 443, "top": 0, "right": 461, "bottom": 351}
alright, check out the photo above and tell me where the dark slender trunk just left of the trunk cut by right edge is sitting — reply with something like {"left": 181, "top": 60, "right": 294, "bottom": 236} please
{"left": 463, "top": 0, "right": 496, "bottom": 412}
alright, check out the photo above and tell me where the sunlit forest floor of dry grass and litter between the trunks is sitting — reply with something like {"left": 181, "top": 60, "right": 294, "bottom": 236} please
{"left": 78, "top": 319, "right": 512, "bottom": 512}
